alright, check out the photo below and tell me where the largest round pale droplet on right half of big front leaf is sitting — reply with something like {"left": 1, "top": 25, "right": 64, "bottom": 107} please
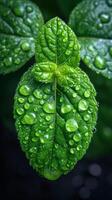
{"left": 66, "top": 119, "right": 78, "bottom": 132}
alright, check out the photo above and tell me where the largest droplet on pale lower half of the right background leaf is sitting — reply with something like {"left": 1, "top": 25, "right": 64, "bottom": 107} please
{"left": 94, "top": 56, "right": 105, "bottom": 69}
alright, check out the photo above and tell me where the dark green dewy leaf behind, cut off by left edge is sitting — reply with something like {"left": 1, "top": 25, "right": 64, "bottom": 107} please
{"left": 0, "top": 0, "right": 43, "bottom": 74}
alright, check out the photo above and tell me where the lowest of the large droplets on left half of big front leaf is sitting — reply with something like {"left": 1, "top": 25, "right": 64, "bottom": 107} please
{"left": 22, "top": 113, "right": 36, "bottom": 125}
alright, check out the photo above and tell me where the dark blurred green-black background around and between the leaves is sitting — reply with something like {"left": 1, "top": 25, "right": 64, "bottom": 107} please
{"left": 0, "top": 0, "right": 112, "bottom": 200}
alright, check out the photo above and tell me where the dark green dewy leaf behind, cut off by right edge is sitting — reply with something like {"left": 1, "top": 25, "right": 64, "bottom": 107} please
{"left": 69, "top": 0, "right": 112, "bottom": 78}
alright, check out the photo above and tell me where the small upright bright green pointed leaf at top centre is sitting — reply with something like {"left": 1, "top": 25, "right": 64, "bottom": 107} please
{"left": 35, "top": 18, "right": 80, "bottom": 67}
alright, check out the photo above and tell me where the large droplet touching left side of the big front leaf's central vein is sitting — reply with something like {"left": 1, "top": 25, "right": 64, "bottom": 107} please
{"left": 43, "top": 102, "right": 55, "bottom": 113}
